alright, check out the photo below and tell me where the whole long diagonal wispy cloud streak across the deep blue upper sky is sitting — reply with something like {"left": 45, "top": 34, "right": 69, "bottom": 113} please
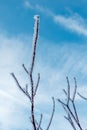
{"left": 25, "top": 1, "right": 87, "bottom": 36}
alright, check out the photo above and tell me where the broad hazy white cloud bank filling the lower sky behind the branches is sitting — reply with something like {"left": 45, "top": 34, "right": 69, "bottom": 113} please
{"left": 0, "top": 30, "right": 87, "bottom": 130}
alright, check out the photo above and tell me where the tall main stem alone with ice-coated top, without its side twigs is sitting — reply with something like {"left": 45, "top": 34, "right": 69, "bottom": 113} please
{"left": 30, "top": 15, "right": 39, "bottom": 130}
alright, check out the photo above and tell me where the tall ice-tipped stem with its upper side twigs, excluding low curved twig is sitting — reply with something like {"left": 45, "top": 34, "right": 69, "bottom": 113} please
{"left": 11, "top": 15, "right": 40, "bottom": 130}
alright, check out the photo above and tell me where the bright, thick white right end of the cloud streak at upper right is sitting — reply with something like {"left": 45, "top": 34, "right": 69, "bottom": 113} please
{"left": 53, "top": 14, "right": 87, "bottom": 36}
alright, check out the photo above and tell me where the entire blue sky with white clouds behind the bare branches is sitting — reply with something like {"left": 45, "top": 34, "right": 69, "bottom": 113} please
{"left": 0, "top": 0, "right": 87, "bottom": 130}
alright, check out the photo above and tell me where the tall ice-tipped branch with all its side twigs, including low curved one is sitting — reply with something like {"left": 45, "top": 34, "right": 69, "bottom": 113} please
{"left": 11, "top": 15, "right": 55, "bottom": 130}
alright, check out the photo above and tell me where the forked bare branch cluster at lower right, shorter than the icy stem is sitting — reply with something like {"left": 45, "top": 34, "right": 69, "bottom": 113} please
{"left": 58, "top": 77, "right": 83, "bottom": 130}
